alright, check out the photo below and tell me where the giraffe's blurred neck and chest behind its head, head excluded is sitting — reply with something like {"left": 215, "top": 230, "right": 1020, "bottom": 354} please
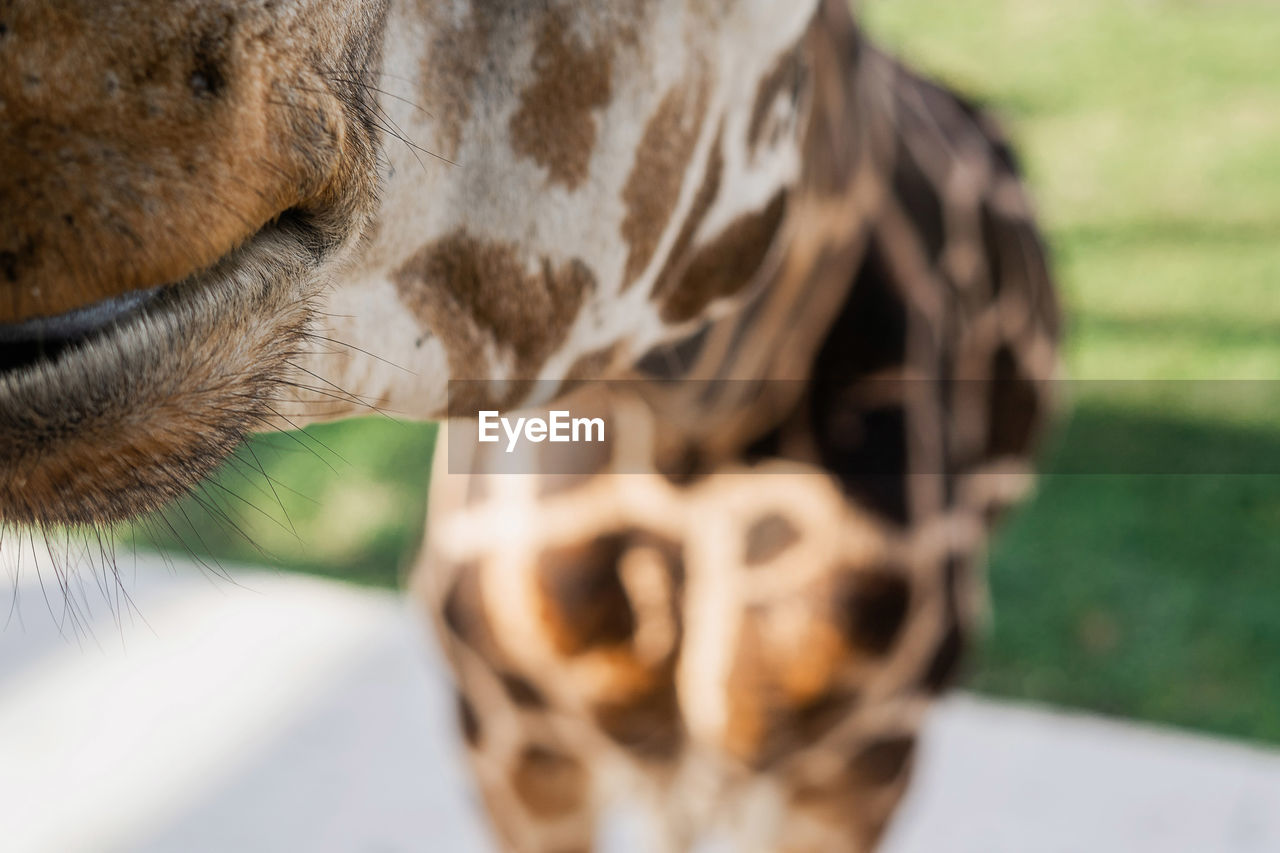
{"left": 413, "top": 4, "right": 1059, "bottom": 852}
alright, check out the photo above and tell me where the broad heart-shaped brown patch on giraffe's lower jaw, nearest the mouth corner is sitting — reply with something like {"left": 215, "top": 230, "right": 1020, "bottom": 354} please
{"left": 393, "top": 231, "right": 595, "bottom": 391}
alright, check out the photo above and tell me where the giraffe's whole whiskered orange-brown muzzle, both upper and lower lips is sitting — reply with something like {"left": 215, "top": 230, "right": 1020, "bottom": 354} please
{"left": 0, "top": 0, "right": 385, "bottom": 532}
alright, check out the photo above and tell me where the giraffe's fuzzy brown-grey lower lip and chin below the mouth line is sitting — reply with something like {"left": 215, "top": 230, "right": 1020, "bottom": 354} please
{"left": 0, "top": 218, "right": 325, "bottom": 528}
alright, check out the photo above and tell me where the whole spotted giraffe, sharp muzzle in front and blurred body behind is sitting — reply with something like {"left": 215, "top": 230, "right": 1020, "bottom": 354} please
{"left": 0, "top": 0, "right": 1059, "bottom": 853}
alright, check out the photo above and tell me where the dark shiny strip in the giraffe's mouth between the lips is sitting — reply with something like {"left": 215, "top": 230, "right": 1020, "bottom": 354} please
{"left": 0, "top": 287, "right": 164, "bottom": 374}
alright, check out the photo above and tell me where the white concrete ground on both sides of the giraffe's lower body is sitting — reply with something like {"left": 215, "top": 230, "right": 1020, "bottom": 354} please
{"left": 0, "top": 545, "right": 1280, "bottom": 853}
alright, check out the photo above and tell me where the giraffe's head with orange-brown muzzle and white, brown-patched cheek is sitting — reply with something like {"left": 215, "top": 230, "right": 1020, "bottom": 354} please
{"left": 0, "top": 0, "right": 817, "bottom": 524}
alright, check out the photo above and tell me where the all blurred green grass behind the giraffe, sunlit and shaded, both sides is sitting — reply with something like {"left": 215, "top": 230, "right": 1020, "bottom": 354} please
{"left": 135, "top": 0, "right": 1280, "bottom": 743}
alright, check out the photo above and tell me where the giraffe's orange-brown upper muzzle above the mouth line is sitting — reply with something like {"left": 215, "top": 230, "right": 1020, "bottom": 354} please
{"left": 0, "top": 0, "right": 371, "bottom": 325}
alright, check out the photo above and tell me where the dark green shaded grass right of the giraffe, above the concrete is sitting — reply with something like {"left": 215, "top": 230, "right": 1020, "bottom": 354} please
{"left": 972, "top": 401, "right": 1280, "bottom": 742}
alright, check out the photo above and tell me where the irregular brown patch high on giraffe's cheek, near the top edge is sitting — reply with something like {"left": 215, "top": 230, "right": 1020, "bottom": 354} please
{"left": 511, "top": 14, "right": 613, "bottom": 190}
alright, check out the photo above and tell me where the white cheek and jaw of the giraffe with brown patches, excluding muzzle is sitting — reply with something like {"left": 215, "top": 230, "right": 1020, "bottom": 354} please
{"left": 291, "top": 0, "right": 829, "bottom": 418}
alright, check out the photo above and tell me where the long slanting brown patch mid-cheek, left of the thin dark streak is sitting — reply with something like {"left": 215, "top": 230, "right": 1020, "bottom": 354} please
{"left": 622, "top": 77, "right": 709, "bottom": 288}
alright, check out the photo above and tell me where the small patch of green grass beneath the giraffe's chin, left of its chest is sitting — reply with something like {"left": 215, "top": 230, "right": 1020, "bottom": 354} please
{"left": 133, "top": 418, "right": 435, "bottom": 587}
